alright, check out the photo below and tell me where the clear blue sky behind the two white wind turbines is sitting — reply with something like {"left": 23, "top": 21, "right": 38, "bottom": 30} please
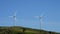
{"left": 0, "top": 0, "right": 60, "bottom": 32}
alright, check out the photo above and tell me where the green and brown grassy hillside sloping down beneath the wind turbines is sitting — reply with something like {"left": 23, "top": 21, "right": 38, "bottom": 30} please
{"left": 0, "top": 26, "right": 60, "bottom": 34}
